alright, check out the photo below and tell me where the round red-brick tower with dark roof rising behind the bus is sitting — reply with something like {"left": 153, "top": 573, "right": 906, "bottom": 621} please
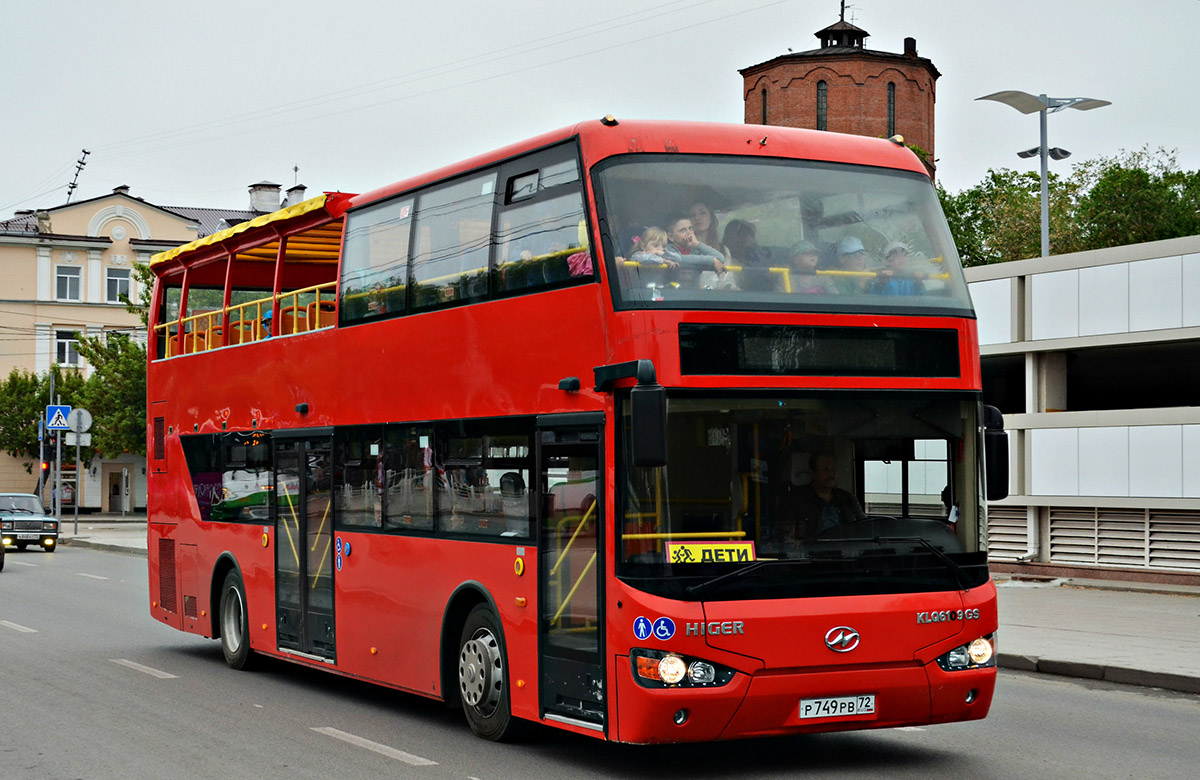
{"left": 738, "top": 2, "right": 941, "bottom": 175}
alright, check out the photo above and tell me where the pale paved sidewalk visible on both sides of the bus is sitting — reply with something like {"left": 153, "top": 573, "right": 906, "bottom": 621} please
{"left": 59, "top": 515, "right": 1200, "bottom": 694}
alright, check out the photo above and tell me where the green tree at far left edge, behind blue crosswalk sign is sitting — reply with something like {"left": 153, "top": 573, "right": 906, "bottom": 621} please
{"left": 0, "top": 364, "right": 85, "bottom": 473}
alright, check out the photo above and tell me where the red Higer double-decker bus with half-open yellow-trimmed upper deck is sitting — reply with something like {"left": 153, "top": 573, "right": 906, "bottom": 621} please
{"left": 148, "top": 118, "right": 1007, "bottom": 743}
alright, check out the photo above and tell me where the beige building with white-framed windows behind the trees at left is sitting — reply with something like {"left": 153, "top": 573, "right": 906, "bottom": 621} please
{"left": 0, "top": 181, "right": 304, "bottom": 511}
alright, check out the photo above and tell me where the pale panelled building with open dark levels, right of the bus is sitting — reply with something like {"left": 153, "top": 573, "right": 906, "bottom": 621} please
{"left": 966, "top": 236, "right": 1200, "bottom": 583}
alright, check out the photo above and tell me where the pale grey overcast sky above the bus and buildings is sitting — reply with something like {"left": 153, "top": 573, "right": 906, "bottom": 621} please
{"left": 0, "top": 0, "right": 1200, "bottom": 213}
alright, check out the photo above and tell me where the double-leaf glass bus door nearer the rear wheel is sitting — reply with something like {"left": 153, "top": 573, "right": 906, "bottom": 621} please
{"left": 274, "top": 431, "right": 336, "bottom": 661}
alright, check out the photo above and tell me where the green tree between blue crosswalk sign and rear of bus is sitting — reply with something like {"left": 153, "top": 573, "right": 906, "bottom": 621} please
{"left": 78, "top": 334, "right": 146, "bottom": 457}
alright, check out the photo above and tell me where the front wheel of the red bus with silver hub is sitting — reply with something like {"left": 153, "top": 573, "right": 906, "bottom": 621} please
{"left": 457, "top": 604, "right": 517, "bottom": 742}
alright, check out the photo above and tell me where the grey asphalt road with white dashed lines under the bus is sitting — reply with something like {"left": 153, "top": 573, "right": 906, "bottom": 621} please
{"left": 0, "top": 547, "right": 1200, "bottom": 780}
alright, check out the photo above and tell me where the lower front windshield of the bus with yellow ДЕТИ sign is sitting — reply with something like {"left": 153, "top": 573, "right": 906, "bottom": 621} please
{"left": 618, "top": 392, "right": 988, "bottom": 600}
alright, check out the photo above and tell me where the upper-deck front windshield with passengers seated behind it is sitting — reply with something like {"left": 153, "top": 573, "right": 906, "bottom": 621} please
{"left": 594, "top": 155, "right": 971, "bottom": 313}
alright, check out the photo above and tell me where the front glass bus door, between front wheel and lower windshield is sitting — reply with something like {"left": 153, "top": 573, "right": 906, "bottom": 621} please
{"left": 536, "top": 414, "right": 605, "bottom": 731}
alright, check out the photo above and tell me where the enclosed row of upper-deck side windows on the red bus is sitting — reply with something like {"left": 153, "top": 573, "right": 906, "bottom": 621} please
{"left": 340, "top": 143, "right": 595, "bottom": 325}
